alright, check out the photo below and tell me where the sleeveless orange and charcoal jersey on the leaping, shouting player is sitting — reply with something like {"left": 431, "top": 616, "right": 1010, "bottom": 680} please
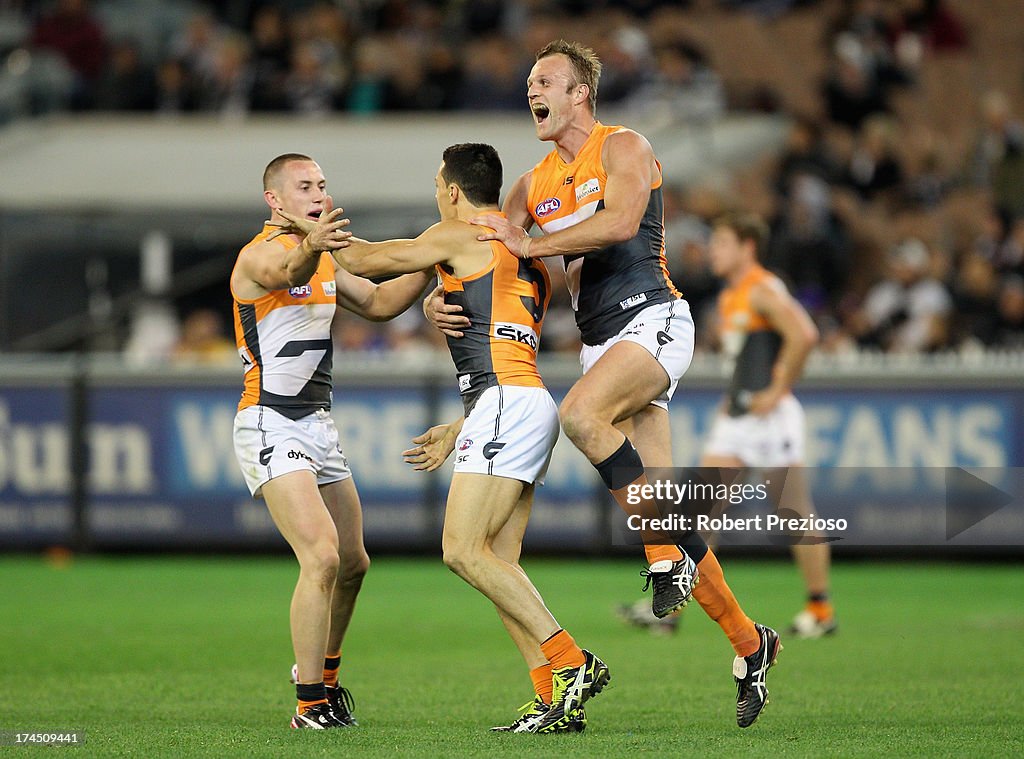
{"left": 526, "top": 123, "right": 681, "bottom": 345}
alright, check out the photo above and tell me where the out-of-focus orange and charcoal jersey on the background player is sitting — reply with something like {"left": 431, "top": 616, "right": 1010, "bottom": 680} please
{"left": 718, "top": 265, "right": 782, "bottom": 415}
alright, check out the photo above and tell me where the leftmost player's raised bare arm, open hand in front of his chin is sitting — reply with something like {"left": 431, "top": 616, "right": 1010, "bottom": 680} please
{"left": 232, "top": 203, "right": 351, "bottom": 297}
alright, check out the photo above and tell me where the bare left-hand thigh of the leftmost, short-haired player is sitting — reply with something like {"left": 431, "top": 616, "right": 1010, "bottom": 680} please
{"left": 262, "top": 469, "right": 337, "bottom": 560}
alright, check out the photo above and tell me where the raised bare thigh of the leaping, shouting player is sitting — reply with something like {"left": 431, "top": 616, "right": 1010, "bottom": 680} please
{"left": 561, "top": 340, "right": 669, "bottom": 424}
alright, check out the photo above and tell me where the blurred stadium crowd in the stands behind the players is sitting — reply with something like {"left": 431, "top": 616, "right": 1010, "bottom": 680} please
{"left": 0, "top": 0, "right": 1024, "bottom": 360}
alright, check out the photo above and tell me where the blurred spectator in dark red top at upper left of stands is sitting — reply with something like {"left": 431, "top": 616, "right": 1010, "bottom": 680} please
{"left": 32, "top": 0, "right": 106, "bottom": 109}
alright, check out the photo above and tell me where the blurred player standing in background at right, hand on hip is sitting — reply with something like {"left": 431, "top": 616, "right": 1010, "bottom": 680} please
{"left": 620, "top": 213, "right": 837, "bottom": 638}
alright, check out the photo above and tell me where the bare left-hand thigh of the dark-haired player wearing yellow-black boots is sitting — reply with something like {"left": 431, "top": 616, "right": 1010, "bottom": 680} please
{"left": 441, "top": 472, "right": 524, "bottom": 551}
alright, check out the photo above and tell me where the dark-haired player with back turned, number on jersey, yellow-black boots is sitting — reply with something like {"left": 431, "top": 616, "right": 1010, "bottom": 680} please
{"left": 278, "top": 143, "right": 609, "bottom": 733}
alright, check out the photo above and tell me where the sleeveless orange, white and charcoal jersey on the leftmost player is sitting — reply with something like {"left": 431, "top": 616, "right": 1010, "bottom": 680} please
{"left": 231, "top": 225, "right": 337, "bottom": 419}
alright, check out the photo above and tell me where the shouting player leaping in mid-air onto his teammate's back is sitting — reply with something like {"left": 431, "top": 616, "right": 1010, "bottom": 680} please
{"left": 430, "top": 40, "right": 780, "bottom": 727}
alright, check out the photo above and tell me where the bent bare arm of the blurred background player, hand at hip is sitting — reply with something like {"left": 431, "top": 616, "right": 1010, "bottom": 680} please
{"left": 750, "top": 278, "right": 818, "bottom": 414}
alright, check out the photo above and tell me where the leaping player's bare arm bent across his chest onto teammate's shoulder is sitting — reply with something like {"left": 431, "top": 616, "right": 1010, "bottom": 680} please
{"left": 473, "top": 129, "right": 657, "bottom": 258}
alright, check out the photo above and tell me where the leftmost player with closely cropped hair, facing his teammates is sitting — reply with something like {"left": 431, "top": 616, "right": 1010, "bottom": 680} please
{"left": 230, "top": 154, "right": 430, "bottom": 729}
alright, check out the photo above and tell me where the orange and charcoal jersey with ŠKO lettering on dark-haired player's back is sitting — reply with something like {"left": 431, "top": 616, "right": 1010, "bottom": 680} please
{"left": 436, "top": 225, "right": 551, "bottom": 415}
